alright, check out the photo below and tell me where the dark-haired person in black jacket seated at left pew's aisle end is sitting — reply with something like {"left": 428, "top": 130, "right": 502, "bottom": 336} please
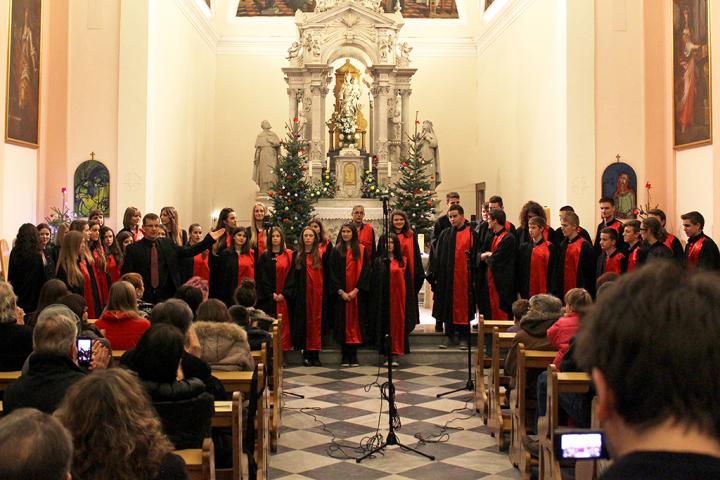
{"left": 127, "top": 323, "right": 215, "bottom": 449}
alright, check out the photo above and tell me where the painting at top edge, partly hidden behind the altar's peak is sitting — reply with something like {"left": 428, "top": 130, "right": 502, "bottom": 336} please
{"left": 236, "top": 0, "right": 458, "bottom": 18}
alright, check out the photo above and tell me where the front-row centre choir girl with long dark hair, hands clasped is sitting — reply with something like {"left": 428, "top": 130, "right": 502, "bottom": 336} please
{"left": 327, "top": 223, "right": 372, "bottom": 367}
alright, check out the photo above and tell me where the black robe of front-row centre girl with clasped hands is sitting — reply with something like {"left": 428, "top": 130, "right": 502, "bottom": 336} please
{"left": 326, "top": 248, "right": 372, "bottom": 345}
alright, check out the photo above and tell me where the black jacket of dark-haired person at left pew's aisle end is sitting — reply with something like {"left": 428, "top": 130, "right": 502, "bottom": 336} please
{"left": 143, "top": 378, "right": 215, "bottom": 450}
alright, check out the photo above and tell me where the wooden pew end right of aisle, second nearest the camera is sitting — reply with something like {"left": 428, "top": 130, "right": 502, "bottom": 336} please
{"left": 510, "top": 343, "right": 557, "bottom": 480}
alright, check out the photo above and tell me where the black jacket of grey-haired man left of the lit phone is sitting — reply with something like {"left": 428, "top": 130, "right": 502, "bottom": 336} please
{"left": 3, "top": 353, "right": 86, "bottom": 414}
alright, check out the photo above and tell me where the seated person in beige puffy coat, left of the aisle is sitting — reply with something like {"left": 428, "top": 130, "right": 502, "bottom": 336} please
{"left": 193, "top": 298, "right": 255, "bottom": 371}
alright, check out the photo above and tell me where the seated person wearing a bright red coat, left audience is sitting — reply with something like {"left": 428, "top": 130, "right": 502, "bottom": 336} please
{"left": 95, "top": 280, "right": 150, "bottom": 350}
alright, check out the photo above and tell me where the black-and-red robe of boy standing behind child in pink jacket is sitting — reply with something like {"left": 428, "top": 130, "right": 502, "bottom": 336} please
{"left": 555, "top": 235, "right": 596, "bottom": 298}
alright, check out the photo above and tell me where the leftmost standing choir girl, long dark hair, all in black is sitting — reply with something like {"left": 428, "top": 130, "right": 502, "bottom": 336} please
{"left": 8, "top": 223, "right": 48, "bottom": 313}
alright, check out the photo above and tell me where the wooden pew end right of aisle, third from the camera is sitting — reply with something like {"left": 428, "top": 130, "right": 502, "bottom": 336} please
{"left": 488, "top": 327, "right": 515, "bottom": 450}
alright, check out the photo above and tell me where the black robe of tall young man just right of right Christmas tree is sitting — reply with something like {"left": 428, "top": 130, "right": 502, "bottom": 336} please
{"left": 428, "top": 223, "right": 480, "bottom": 332}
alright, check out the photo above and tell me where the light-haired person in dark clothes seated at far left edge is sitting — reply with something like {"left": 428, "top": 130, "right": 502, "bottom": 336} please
{"left": 0, "top": 281, "right": 33, "bottom": 372}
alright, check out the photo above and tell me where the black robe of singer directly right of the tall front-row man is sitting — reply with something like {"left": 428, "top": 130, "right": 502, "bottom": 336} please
{"left": 474, "top": 228, "right": 517, "bottom": 320}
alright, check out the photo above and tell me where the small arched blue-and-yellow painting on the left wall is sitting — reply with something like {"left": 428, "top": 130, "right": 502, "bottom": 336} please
{"left": 74, "top": 160, "right": 110, "bottom": 217}
